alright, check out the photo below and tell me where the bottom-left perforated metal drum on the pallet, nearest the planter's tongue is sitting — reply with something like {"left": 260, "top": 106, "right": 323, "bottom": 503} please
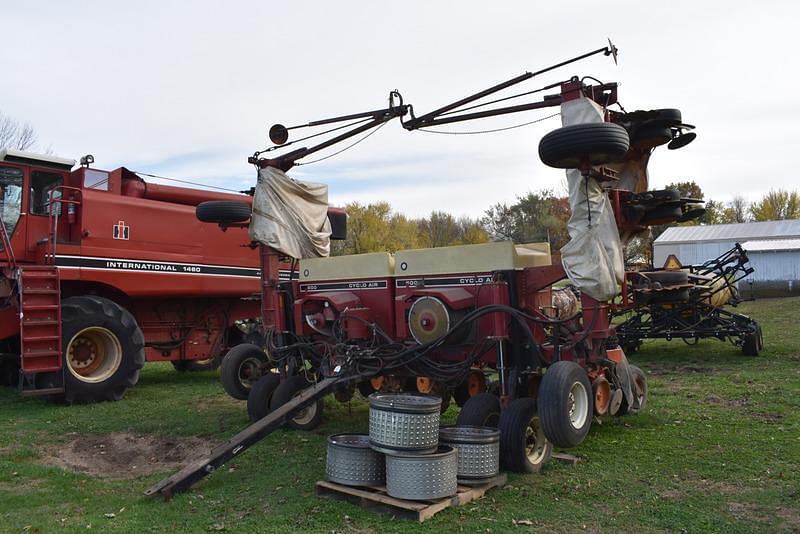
{"left": 325, "top": 434, "right": 386, "bottom": 486}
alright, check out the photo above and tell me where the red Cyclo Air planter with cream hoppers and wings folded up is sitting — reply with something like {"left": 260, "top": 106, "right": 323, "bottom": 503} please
{"left": 146, "top": 43, "right": 703, "bottom": 497}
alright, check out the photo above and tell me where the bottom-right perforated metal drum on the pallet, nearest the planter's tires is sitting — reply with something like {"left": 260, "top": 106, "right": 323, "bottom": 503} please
{"left": 439, "top": 426, "right": 500, "bottom": 484}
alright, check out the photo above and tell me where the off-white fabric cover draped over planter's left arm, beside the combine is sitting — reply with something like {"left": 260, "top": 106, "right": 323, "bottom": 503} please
{"left": 250, "top": 167, "right": 331, "bottom": 259}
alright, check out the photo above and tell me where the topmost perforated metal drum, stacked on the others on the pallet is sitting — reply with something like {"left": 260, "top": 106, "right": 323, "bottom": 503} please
{"left": 369, "top": 393, "right": 442, "bottom": 454}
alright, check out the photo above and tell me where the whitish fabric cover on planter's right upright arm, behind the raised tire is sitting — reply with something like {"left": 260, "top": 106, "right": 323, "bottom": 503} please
{"left": 561, "top": 98, "right": 625, "bottom": 301}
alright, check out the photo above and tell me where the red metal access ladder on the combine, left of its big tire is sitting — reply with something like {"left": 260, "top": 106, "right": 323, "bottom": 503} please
{"left": 19, "top": 265, "right": 64, "bottom": 395}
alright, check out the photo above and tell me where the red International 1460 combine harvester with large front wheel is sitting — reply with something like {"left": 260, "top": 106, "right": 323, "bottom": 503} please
{"left": 0, "top": 150, "right": 272, "bottom": 402}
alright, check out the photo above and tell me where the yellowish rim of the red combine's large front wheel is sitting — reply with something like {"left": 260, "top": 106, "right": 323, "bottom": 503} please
{"left": 66, "top": 326, "right": 122, "bottom": 383}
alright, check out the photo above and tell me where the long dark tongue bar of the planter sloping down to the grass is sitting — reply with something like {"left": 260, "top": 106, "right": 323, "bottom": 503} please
{"left": 144, "top": 375, "right": 358, "bottom": 500}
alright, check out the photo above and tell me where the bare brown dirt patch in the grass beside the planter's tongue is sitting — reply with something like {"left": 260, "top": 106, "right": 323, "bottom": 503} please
{"left": 42, "top": 432, "right": 215, "bottom": 479}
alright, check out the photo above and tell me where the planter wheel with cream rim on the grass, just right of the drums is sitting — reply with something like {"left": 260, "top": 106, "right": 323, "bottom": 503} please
{"left": 499, "top": 397, "right": 553, "bottom": 473}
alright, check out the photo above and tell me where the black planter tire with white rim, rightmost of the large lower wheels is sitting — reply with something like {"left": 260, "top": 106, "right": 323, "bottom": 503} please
{"left": 538, "top": 361, "right": 594, "bottom": 447}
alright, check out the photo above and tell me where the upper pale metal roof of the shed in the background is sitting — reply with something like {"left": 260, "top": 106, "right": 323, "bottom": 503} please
{"left": 654, "top": 219, "right": 800, "bottom": 244}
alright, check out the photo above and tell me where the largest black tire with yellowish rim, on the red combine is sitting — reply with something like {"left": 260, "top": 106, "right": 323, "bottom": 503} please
{"left": 61, "top": 296, "right": 144, "bottom": 403}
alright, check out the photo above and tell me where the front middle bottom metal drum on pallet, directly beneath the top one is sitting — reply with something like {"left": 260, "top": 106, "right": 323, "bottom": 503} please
{"left": 386, "top": 446, "right": 458, "bottom": 501}
